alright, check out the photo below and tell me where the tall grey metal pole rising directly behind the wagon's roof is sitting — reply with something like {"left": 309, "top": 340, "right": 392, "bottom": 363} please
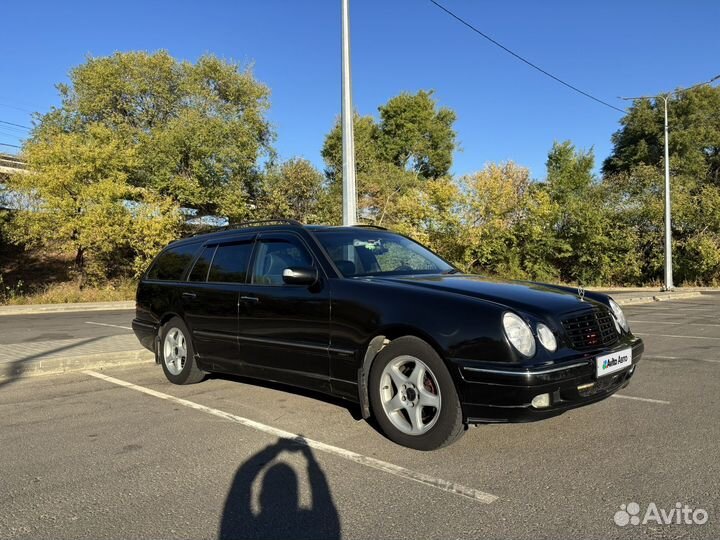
{"left": 341, "top": 0, "right": 357, "bottom": 225}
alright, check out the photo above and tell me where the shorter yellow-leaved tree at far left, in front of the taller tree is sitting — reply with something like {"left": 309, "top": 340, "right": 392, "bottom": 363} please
{"left": 8, "top": 123, "right": 180, "bottom": 285}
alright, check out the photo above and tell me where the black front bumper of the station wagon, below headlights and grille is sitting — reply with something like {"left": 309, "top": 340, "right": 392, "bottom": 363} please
{"left": 455, "top": 336, "right": 645, "bottom": 424}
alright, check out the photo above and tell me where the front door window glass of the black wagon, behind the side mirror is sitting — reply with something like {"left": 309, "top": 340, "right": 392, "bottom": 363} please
{"left": 252, "top": 237, "right": 313, "bottom": 286}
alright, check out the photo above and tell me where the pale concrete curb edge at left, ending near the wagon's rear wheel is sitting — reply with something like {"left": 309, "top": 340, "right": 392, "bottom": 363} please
{"left": 0, "top": 349, "right": 155, "bottom": 383}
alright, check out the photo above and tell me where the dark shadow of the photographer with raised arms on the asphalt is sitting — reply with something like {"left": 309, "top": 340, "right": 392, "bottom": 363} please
{"left": 218, "top": 437, "right": 341, "bottom": 540}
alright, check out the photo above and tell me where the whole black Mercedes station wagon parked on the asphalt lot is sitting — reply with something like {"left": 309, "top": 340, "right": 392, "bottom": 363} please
{"left": 132, "top": 220, "right": 643, "bottom": 450}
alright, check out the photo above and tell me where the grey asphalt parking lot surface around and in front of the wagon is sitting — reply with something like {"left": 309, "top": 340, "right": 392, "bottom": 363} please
{"left": 0, "top": 296, "right": 720, "bottom": 539}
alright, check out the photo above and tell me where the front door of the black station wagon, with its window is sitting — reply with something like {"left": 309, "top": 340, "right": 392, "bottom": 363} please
{"left": 238, "top": 232, "right": 330, "bottom": 391}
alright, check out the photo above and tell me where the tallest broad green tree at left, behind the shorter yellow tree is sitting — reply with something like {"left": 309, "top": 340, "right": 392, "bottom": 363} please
{"left": 32, "top": 51, "right": 273, "bottom": 214}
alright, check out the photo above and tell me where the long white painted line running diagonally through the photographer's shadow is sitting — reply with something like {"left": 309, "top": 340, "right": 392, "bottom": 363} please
{"left": 83, "top": 370, "right": 498, "bottom": 504}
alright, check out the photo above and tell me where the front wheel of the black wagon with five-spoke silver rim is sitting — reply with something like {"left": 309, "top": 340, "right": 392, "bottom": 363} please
{"left": 368, "top": 336, "right": 465, "bottom": 450}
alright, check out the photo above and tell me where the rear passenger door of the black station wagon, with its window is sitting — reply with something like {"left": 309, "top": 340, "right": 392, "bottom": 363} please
{"left": 182, "top": 235, "right": 254, "bottom": 372}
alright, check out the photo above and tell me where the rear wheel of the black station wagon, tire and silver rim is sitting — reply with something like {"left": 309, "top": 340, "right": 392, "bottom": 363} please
{"left": 158, "top": 317, "right": 207, "bottom": 384}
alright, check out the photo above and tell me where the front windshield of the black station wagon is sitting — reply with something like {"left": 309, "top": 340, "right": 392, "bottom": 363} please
{"left": 316, "top": 229, "right": 455, "bottom": 277}
